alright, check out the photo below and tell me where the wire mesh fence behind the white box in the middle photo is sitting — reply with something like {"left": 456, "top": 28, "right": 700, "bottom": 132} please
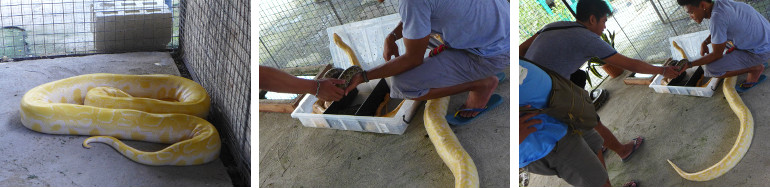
{"left": 259, "top": 0, "right": 398, "bottom": 69}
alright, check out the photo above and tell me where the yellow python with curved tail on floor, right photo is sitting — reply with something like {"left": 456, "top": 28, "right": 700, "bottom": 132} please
{"left": 666, "top": 42, "right": 754, "bottom": 181}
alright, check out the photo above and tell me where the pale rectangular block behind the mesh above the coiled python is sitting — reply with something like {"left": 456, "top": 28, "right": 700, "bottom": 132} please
{"left": 91, "top": 0, "right": 172, "bottom": 51}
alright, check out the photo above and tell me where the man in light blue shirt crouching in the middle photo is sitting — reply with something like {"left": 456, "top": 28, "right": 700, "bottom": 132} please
{"left": 346, "top": 0, "right": 510, "bottom": 123}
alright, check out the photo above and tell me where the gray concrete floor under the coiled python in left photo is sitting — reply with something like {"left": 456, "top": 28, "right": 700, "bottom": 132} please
{"left": 0, "top": 52, "right": 232, "bottom": 187}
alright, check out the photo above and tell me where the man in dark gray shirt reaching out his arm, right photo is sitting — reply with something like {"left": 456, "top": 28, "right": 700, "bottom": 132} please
{"left": 519, "top": 0, "right": 680, "bottom": 181}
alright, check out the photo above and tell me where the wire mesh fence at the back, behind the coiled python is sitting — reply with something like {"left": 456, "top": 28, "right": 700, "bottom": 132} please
{"left": 0, "top": 0, "right": 179, "bottom": 58}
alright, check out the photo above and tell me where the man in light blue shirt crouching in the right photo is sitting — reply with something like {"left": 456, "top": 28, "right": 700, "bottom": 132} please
{"left": 677, "top": 0, "right": 770, "bottom": 93}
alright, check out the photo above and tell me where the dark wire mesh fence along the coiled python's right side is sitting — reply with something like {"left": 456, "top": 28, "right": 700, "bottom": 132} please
{"left": 180, "top": 0, "right": 251, "bottom": 186}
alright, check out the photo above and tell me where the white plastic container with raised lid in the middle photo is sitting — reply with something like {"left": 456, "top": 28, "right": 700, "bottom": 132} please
{"left": 291, "top": 14, "right": 421, "bottom": 134}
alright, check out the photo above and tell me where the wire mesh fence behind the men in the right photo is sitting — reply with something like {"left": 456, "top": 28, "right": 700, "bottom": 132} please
{"left": 519, "top": 0, "right": 770, "bottom": 89}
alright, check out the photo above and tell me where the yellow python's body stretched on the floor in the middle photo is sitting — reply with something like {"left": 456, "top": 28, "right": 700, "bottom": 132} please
{"left": 424, "top": 97, "right": 479, "bottom": 188}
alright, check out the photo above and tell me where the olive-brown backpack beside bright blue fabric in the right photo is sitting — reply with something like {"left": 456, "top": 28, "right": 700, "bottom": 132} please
{"left": 519, "top": 57, "right": 599, "bottom": 135}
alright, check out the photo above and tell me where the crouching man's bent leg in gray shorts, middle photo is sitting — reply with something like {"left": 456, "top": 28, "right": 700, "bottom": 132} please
{"left": 389, "top": 49, "right": 510, "bottom": 117}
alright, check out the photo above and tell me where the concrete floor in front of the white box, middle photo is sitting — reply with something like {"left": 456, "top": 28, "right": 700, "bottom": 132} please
{"left": 259, "top": 70, "right": 511, "bottom": 187}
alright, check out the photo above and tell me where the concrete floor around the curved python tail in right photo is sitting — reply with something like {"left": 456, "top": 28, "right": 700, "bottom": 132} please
{"left": 529, "top": 71, "right": 770, "bottom": 187}
